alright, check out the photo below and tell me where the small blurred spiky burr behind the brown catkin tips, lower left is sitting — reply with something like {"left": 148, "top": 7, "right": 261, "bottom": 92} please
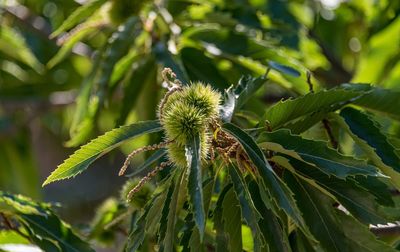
{"left": 120, "top": 179, "right": 154, "bottom": 209}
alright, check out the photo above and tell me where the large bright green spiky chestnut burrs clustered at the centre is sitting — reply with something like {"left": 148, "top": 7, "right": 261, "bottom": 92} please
{"left": 159, "top": 83, "right": 221, "bottom": 167}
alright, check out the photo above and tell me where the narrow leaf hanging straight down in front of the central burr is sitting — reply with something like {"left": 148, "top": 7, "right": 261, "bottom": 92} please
{"left": 185, "top": 135, "right": 206, "bottom": 240}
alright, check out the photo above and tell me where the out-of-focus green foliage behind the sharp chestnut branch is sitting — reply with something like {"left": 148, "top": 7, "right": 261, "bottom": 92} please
{"left": 0, "top": 0, "right": 400, "bottom": 236}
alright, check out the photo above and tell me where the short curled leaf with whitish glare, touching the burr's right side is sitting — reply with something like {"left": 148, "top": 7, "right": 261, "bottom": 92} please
{"left": 220, "top": 76, "right": 267, "bottom": 122}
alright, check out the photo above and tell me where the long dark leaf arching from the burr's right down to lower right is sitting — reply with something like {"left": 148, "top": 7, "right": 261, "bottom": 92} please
{"left": 222, "top": 123, "right": 308, "bottom": 239}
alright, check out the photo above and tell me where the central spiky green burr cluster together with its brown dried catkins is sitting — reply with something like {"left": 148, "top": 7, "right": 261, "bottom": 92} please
{"left": 119, "top": 69, "right": 221, "bottom": 201}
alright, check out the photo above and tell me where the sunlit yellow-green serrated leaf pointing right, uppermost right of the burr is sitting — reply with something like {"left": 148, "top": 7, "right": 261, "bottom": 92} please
{"left": 264, "top": 88, "right": 363, "bottom": 129}
